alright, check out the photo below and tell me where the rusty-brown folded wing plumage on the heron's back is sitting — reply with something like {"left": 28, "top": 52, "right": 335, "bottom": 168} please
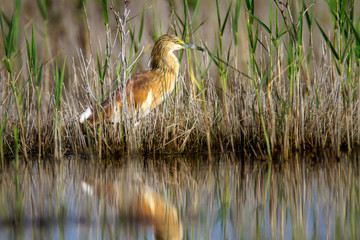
{"left": 87, "top": 71, "right": 155, "bottom": 125}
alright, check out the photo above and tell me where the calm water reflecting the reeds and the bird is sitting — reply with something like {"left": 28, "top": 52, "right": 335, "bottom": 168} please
{"left": 0, "top": 153, "right": 360, "bottom": 239}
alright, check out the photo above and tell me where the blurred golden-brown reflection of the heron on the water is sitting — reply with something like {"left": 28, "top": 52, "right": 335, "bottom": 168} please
{"left": 81, "top": 181, "right": 183, "bottom": 240}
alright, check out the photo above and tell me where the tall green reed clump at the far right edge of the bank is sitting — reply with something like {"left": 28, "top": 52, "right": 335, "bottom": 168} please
{"left": 316, "top": 0, "right": 359, "bottom": 153}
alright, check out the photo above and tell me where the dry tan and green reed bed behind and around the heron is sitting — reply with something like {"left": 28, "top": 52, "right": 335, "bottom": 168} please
{"left": 0, "top": 0, "right": 360, "bottom": 160}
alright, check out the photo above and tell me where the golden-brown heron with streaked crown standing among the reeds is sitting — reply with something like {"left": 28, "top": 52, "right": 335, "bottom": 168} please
{"left": 80, "top": 34, "right": 204, "bottom": 126}
